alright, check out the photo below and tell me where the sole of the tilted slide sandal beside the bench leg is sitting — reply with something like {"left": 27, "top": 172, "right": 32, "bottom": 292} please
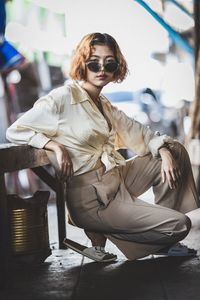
{"left": 63, "top": 239, "right": 117, "bottom": 263}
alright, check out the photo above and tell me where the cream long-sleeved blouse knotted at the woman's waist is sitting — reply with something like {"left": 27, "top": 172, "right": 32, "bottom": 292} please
{"left": 6, "top": 82, "right": 170, "bottom": 175}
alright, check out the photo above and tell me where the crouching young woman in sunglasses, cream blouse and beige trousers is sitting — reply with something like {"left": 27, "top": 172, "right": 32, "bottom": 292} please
{"left": 7, "top": 33, "right": 199, "bottom": 261}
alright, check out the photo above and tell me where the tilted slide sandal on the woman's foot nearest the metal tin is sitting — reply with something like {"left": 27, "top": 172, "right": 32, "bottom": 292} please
{"left": 63, "top": 238, "right": 117, "bottom": 262}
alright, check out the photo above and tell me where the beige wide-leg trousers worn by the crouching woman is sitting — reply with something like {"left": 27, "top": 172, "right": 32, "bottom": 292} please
{"left": 67, "top": 142, "right": 199, "bottom": 259}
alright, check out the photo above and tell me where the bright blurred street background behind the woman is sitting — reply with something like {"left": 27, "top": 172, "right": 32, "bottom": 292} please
{"left": 0, "top": 0, "right": 200, "bottom": 195}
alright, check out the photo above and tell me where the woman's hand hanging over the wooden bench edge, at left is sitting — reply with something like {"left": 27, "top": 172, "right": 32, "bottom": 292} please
{"left": 44, "top": 141, "right": 74, "bottom": 181}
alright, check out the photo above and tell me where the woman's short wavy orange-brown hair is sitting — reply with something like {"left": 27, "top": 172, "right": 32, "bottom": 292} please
{"left": 69, "top": 32, "right": 128, "bottom": 82}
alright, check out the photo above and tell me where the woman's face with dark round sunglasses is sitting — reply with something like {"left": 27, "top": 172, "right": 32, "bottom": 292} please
{"left": 86, "top": 45, "right": 117, "bottom": 88}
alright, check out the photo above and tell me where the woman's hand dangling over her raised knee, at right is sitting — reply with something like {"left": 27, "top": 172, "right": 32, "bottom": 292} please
{"left": 159, "top": 148, "right": 181, "bottom": 189}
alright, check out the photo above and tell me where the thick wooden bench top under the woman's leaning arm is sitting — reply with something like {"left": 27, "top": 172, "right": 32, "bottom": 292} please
{"left": 0, "top": 144, "right": 50, "bottom": 174}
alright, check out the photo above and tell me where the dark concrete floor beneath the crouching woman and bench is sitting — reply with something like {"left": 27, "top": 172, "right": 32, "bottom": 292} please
{"left": 0, "top": 192, "right": 200, "bottom": 300}
